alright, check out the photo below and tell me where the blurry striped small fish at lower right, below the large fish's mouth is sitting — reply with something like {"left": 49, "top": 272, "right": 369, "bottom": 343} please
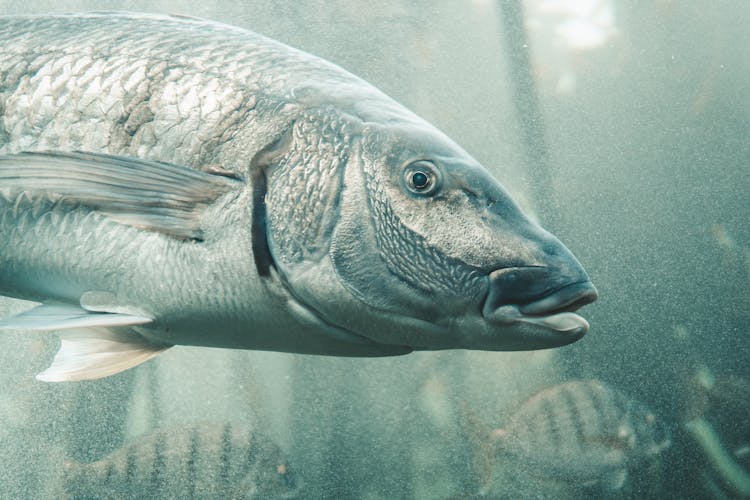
{"left": 490, "top": 379, "right": 671, "bottom": 491}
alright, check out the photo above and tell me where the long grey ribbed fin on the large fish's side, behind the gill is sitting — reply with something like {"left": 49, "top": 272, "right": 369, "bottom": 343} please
{"left": 0, "top": 152, "right": 241, "bottom": 239}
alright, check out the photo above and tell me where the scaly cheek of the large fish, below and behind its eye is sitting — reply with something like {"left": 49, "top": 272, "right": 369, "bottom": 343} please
{"left": 330, "top": 151, "right": 481, "bottom": 322}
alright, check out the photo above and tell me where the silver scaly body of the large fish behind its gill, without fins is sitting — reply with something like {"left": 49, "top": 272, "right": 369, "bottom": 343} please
{"left": 0, "top": 16, "right": 382, "bottom": 351}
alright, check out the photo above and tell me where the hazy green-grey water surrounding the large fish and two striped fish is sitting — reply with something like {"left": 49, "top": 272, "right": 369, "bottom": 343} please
{"left": 0, "top": 0, "right": 750, "bottom": 499}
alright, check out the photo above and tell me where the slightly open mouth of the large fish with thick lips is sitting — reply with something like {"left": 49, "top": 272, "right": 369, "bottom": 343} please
{"left": 482, "top": 266, "right": 598, "bottom": 336}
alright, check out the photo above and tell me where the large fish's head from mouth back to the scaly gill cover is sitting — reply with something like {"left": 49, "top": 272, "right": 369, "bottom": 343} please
{"left": 264, "top": 113, "right": 597, "bottom": 350}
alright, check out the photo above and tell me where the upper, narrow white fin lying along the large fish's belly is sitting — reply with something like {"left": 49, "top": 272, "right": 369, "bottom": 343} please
{"left": 0, "top": 302, "right": 152, "bottom": 331}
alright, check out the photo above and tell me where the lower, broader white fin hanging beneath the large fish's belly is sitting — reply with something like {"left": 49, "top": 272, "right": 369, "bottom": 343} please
{"left": 36, "top": 328, "right": 171, "bottom": 382}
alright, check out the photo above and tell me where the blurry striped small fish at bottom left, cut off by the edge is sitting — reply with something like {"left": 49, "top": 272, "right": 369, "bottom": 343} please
{"left": 64, "top": 424, "right": 298, "bottom": 499}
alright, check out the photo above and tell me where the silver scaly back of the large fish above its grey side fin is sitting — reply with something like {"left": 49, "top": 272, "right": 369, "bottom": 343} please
{"left": 0, "top": 14, "right": 366, "bottom": 168}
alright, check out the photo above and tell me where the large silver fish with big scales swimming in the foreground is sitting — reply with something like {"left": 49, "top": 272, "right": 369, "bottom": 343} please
{"left": 0, "top": 13, "right": 597, "bottom": 382}
